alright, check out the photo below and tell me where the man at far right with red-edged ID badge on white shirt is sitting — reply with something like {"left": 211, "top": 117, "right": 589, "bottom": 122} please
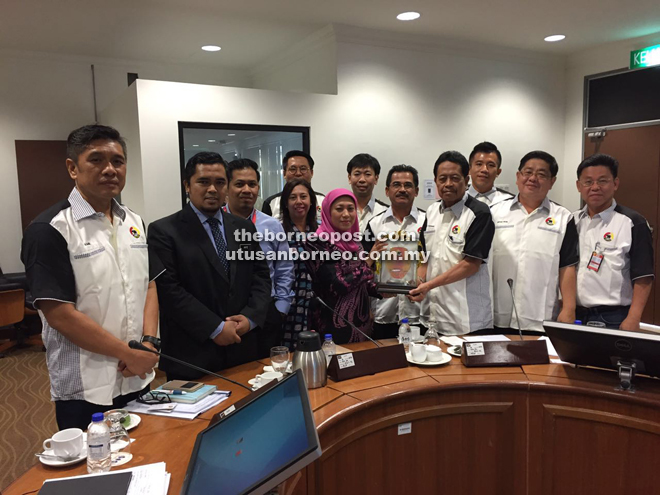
{"left": 573, "top": 154, "right": 654, "bottom": 330}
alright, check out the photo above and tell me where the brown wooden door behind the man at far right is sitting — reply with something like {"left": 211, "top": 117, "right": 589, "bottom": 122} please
{"left": 584, "top": 125, "right": 660, "bottom": 325}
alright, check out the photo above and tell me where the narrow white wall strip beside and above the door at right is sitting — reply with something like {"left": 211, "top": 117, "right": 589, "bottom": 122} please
{"left": 561, "top": 33, "right": 660, "bottom": 210}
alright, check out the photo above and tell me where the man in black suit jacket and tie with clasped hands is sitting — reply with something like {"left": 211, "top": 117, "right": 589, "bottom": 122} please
{"left": 149, "top": 153, "right": 271, "bottom": 380}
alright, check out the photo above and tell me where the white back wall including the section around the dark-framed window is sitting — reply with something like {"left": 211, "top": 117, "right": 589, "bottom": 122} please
{"left": 116, "top": 33, "right": 565, "bottom": 221}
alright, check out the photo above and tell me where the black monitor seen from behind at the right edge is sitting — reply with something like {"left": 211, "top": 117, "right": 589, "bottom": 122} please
{"left": 543, "top": 321, "right": 660, "bottom": 389}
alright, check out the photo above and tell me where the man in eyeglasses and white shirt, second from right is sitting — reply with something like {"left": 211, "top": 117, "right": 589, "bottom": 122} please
{"left": 491, "top": 151, "right": 579, "bottom": 332}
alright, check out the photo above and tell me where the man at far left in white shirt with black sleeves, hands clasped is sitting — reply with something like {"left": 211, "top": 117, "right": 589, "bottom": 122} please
{"left": 21, "top": 125, "right": 162, "bottom": 429}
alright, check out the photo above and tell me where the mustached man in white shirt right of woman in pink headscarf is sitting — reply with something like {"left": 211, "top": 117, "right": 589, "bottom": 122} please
{"left": 364, "top": 165, "right": 426, "bottom": 339}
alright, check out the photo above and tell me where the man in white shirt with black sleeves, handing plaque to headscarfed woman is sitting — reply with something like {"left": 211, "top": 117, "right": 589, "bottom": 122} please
{"left": 410, "top": 151, "right": 493, "bottom": 335}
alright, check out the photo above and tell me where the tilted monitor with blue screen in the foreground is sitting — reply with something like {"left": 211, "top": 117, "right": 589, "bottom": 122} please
{"left": 181, "top": 370, "right": 321, "bottom": 495}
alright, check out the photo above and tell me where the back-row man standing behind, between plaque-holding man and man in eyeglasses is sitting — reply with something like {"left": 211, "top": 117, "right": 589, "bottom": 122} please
{"left": 468, "top": 141, "right": 513, "bottom": 206}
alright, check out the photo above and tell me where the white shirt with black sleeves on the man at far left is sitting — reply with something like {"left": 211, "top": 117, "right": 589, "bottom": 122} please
{"left": 21, "top": 188, "right": 159, "bottom": 405}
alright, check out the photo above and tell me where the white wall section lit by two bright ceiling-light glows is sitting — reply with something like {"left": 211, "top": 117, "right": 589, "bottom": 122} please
{"left": 332, "top": 39, "right": 564, "bottom": 208}
